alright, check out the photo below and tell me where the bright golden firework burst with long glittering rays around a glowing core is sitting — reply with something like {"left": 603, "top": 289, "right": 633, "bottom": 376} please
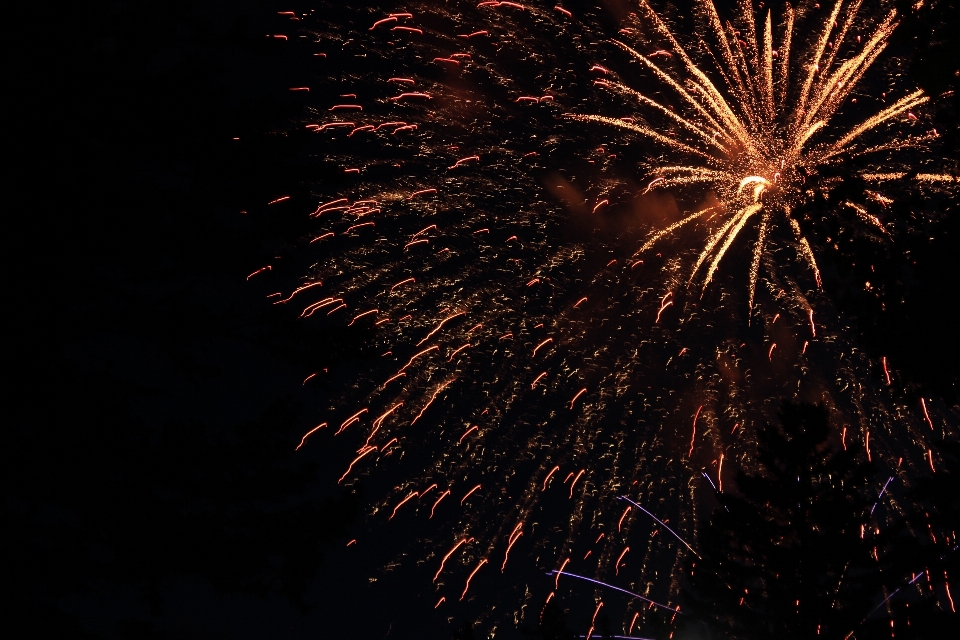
{"left": 569, "top": 0, "right": 952, "bottom": 310}
